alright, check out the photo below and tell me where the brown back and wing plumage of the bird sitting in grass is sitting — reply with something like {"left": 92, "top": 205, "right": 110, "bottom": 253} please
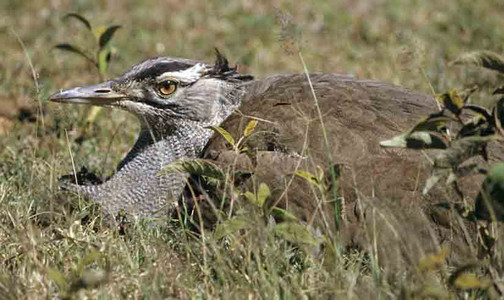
{"left": 207, "top": 74, "right": 484, "bottom": 266}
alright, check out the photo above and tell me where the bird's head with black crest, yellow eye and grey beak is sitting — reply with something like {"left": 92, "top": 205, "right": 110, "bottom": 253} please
{"left": 50, "top": 51, "right": 253, "bottom": 128}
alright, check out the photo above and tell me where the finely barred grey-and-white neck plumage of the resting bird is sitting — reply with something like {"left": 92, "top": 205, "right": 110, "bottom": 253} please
{"left": 67, "top": 99, "right": 243, "bottom": 216}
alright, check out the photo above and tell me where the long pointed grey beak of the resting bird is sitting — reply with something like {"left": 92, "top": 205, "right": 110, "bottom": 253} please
{"left": 49, "top": 81, "right": 128, "bottom": 106}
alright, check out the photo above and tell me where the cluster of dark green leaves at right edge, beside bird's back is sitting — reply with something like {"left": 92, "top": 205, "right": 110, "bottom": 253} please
{"left": 381, "top": 90, "right": 504, "bottom": 196}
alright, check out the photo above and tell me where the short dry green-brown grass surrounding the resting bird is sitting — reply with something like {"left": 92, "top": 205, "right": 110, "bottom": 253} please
{"left": 0, "top": 0, "right": 504, "bottom": 299}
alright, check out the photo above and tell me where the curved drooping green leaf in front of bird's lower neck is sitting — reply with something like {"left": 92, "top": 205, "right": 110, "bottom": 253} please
{"left": 157, "top": 158, "right": 226, "bottom": 179}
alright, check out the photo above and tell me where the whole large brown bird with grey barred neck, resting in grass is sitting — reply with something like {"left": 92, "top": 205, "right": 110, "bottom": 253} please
{"left": 51, "top": 53, "right": 488, "bottom": 266}
